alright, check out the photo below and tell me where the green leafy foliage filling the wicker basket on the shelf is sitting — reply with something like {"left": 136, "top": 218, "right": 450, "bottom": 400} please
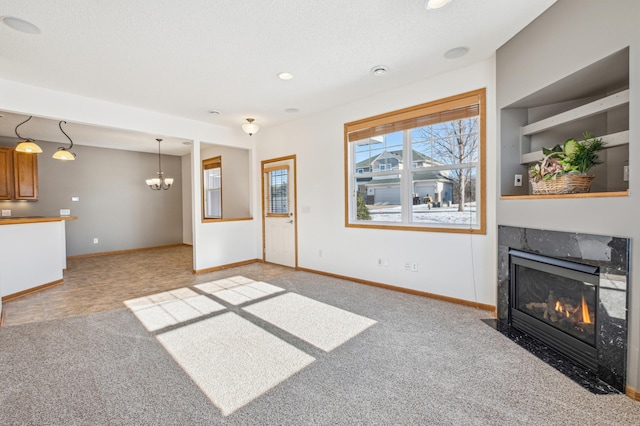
{"left": 529, "top": 132, "right": 605, "bottom": 182}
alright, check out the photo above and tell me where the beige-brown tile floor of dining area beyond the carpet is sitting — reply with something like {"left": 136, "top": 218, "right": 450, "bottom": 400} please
{"left": 2, "top": 246, "right": 293, "bottom": 326}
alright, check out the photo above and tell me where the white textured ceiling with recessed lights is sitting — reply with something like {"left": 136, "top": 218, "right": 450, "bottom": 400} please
{"left": 0, "top": 0, "right": 555, "bottom": 155}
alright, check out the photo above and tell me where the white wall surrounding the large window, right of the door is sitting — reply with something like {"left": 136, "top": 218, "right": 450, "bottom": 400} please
{"left": 255, "top": 58, "right": 496, "bottom": 305}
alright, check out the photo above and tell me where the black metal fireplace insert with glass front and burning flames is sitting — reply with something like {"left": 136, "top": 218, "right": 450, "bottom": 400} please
{"left": 509, "top": 250, "right": 600, "bottom": 372}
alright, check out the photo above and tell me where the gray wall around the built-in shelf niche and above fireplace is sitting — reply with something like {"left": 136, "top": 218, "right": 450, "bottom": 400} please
{"left": 496, "top": 0, "right": 640, "bottom": 389}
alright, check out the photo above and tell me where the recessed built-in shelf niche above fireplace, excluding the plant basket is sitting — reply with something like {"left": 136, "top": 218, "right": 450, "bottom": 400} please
{"left": 500, "top": 47, "right": 634, "bottom": 200}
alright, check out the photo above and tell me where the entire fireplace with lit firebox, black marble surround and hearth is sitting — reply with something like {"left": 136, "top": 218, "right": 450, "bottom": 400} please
{"left": 495, "top": 225, "right": 630, "bottom": 393}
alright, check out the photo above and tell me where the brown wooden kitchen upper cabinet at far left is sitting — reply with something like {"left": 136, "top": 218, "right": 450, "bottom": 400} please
{"left": 0, "top": 147, "right": 38, "bottom": 201}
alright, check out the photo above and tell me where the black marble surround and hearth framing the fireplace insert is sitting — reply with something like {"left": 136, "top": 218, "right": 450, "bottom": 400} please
{"left": 496, "top": 225, "right": 630, "bottom": 393}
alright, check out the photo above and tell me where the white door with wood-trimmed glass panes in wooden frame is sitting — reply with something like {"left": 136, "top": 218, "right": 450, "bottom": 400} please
{"left": 262, "top": 156, "right": 298, "bottom": 268}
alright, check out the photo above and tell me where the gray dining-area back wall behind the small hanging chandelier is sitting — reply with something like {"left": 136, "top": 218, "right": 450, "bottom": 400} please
{"left": 0, "top": 140, "right": 183, "bottom": 256}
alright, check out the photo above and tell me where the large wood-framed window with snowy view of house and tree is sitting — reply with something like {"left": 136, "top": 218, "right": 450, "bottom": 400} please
{"left": 344, "top": 89, "right": 485, "bottom": 234}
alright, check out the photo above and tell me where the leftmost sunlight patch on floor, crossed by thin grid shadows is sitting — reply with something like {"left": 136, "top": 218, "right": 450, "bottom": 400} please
{"left": 124, "top": 288, "right": 225, "bottom": 331}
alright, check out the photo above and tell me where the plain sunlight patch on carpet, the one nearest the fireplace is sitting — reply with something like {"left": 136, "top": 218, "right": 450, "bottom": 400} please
{"left": 243, "top": 293, "right": 376, "bottom": 352}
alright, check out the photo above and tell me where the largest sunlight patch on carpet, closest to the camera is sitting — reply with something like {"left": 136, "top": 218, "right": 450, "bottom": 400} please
{"left": 157, "top": 313, "right": 315, "bottom": 416}
